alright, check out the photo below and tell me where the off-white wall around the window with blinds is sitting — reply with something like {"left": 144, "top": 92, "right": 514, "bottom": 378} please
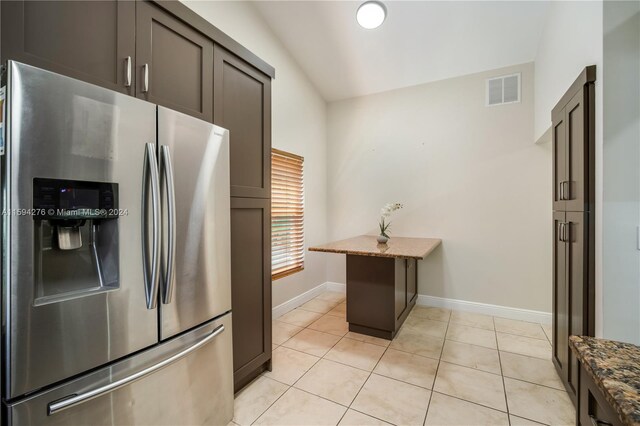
{"left": 184, "top": 1, "right": 327, "bottom": 306}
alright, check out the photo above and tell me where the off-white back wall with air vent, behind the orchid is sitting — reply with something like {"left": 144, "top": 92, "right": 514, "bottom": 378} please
{"left": 327, "top": 60, "right": 551, "bottom": 312}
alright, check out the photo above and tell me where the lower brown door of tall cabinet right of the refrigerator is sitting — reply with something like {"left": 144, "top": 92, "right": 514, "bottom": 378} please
{"left": 231, "top": 198, "right": 271, "bottom": 391}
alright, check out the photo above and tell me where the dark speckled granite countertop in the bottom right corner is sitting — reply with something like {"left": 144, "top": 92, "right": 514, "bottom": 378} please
{"left": 569, "top": 336, "right": 640, "bottom": 425}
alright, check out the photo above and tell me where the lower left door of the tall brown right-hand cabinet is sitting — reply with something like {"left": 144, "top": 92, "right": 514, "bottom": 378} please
{"left": 552, "top": 212, "right": 570, "bottom": 382}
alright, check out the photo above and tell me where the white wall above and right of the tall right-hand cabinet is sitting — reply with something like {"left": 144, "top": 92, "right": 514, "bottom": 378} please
{"left": 534, "top": 0, "right": 605, "bottom": 337}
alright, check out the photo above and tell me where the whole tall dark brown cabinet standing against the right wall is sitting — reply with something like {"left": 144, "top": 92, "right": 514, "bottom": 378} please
{"left": 552, "top": 66, "right": 596, "bottom": 403}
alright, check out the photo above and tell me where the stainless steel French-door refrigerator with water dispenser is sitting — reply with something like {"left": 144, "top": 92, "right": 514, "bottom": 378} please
{"left": 0, "top": 61, "right": 233, "bottom": 425}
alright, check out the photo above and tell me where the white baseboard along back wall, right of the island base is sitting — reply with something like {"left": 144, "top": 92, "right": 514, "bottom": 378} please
{"left": 416, "top": 294, "right": 551, "bottom": 324}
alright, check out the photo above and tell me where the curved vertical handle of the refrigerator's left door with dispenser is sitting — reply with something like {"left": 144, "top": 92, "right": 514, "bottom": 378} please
{"left": 142, "top": 143, "right": 160, "bottom": 309}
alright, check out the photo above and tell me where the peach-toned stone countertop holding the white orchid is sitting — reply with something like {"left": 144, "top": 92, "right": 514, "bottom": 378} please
{"left": 309, "top": 235, "right": 442, "bottom": 259}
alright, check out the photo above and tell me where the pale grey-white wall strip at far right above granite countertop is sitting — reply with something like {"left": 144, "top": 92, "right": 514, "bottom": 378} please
{"left": 602, "top": 1, "right": 640, "bottom": 344}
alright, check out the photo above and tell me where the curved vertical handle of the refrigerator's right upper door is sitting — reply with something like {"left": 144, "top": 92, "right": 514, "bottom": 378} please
{"left": 160, "top": 145, "right": 176, "bottom": 305}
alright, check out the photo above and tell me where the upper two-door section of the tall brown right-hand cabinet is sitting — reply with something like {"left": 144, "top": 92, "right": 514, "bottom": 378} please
{"left": 552, "top": 66, "right": 595, "bottom": 211}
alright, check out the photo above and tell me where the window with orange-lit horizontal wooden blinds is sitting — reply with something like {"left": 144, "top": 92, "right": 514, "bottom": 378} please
{"left": 271, "top": 149, "right": 304, "bottom": 280}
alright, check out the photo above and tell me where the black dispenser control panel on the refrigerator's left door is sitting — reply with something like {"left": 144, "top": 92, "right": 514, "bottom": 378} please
{"left": 33, "top": 178, "right": 120, "bottom": 219}
